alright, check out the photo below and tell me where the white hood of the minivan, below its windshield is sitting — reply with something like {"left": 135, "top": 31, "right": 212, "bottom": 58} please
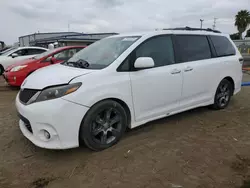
{"left": 21, "top": 64, "right": 96, "bottom": 90}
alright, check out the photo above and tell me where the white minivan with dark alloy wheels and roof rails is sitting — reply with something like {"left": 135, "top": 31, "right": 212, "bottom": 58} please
{"left": 16, "top": 28, "right": 243, "bottom": 151}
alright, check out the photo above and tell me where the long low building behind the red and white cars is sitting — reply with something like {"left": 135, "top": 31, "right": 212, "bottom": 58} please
{"left": 19, "top": 32, "right": 117, "bottom": 48}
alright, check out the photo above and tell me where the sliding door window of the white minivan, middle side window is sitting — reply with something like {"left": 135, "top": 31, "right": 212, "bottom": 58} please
{"left": 175, "top": 35, "right": 212, "bottom": 62}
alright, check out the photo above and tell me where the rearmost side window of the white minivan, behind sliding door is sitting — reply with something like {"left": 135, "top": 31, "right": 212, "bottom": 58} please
{"left": 210, "top": 36, "right": 236, "bottom": 57}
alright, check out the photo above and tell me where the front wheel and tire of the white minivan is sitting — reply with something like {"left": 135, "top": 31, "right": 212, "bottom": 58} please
{"left": 79, "top": 100, "right": 128, "bottom": 151}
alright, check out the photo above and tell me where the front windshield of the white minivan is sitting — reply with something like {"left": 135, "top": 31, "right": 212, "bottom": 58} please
{"left": 63, "top": 36, "right": 139, "bottom": 69}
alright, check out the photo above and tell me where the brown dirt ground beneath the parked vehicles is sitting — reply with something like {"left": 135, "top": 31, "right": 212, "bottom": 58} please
{"left": 0, "top": 75, "right": 250, "bottom": 188}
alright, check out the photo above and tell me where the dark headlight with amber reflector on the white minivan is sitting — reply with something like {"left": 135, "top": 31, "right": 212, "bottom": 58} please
{"left": 35, "top": 83, "right": 82, "bottom": 102}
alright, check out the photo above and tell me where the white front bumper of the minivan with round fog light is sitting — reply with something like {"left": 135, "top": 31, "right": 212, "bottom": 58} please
{"left": 16, "top": 94, "right": 89, "bottom": 149}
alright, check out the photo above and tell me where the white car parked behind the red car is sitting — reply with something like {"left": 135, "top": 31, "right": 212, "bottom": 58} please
{"left": 0, "top": 46, "right": 48, "bottom": 75}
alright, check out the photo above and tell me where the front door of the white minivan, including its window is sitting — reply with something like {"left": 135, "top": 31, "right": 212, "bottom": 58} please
{"left": 130, "top": 35, "right": 182, "bottom": 121}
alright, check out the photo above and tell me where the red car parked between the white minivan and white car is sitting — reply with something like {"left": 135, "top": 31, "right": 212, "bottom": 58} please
{"left": 3, "top": 46, "right": 85, "bottom": 86}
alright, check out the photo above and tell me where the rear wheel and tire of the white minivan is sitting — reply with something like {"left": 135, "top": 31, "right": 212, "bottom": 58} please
{"left": 212, "top": 79, "right": 233, "bottom": 110}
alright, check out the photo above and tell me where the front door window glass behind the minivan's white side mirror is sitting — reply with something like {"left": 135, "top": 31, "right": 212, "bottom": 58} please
{"left": 135, "top": 36, "right": 175, "bottom": 67}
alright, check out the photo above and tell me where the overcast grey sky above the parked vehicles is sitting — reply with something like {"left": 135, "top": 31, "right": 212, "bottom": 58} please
{"left": 0, "top": 0, "right": 250, "bottom": 44}
